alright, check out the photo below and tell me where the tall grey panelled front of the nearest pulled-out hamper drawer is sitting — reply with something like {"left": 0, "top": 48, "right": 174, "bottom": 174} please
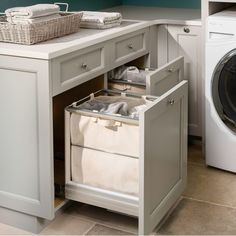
{"left": 139, "top": 81, "right": 188, "bottom": 235}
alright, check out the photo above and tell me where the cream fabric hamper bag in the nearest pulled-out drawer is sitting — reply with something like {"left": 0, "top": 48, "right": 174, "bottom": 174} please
{"left": 66, "top": 90, "right": 156, "bottom": 196}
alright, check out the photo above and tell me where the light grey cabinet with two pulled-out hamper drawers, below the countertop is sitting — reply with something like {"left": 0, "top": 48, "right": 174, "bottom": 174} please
{"left": 0, "top": 24, "right": 187, "bottom": 234}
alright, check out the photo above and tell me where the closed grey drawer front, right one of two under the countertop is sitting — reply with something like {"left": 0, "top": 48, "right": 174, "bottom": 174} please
{"left": 114, "top": 30, "right": 148, "bottom": 65}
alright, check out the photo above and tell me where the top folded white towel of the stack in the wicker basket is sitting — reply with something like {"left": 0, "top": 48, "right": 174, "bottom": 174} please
{"left": 5, "top": 4, "right": 60, "bottom": 19}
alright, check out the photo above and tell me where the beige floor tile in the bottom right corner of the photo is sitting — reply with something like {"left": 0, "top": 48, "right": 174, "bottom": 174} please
{"left": 158, "top": 199, "right": 236, "bottom": 235}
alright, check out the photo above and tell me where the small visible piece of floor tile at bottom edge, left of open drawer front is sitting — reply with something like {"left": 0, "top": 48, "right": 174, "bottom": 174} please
{"left": 86, "top": 224, "right": 132, "bottom": 235}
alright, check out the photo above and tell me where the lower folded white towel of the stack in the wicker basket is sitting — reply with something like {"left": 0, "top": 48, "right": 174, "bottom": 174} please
{"left": 7, "top": 13, "right": 61, "bottom": 24}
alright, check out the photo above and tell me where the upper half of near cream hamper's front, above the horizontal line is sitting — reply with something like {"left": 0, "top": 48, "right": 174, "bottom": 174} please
{"left": 70, "top": 113, "right": 139, "bottom": 157}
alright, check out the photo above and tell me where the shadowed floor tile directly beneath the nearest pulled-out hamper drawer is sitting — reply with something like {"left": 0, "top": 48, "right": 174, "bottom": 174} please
{"left": 65, "top": 203, "right": 138, "bottom": 234}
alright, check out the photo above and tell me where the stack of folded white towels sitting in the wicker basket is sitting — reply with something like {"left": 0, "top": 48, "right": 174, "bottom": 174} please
{"left": 5, "top": 4, "right": 61, "bottom": 24}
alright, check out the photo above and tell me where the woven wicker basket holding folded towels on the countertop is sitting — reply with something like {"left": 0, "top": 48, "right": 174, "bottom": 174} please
{"left": 0, "top": 12, "right": 83, "bottom": 45}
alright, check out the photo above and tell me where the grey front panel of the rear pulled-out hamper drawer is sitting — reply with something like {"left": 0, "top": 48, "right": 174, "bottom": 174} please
{"left": 146, "top": 56, "right": 184, "bottom": 96}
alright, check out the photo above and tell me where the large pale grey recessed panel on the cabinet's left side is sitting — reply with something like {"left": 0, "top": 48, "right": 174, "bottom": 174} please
{"left": 0, "top": 56, "right": 54, "bottom": 219}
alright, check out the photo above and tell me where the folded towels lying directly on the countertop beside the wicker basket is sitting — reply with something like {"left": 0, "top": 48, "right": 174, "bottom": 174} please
{"left": 80, "top": 11, "right": 122, "bottom": 29}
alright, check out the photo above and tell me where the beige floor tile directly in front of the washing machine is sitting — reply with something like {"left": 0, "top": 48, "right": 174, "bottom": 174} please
{"left": 184, "top": 165, "right": 236, "bottom": 207}
